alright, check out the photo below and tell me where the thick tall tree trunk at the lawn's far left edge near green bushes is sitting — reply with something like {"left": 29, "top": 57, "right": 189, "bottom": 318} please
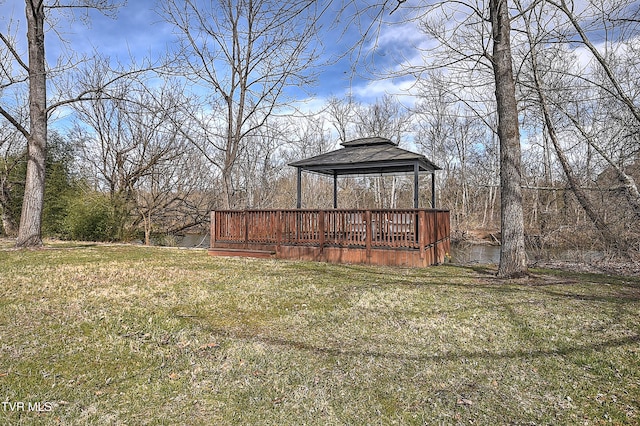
{"left": 16, "top": 0, "right": 47, "bottom": 247}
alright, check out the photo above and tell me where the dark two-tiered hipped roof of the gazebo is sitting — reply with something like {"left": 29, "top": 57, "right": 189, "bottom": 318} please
{"left": 289, "top": 137, "right": 441, "bottom": 176}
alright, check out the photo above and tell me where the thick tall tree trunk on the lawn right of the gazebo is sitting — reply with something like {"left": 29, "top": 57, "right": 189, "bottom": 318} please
{"left": 489, "top": 0, "right": 528, "bottom": 278}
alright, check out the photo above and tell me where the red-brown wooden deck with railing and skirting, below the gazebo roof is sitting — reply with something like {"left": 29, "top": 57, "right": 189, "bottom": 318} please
{"left": 209, "top": 209, "right": 450, "bottom": 267}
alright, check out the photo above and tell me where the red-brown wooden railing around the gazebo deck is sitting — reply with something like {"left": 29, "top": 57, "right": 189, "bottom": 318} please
{"left": 211, "top": 209, "right": 450, "bottom": 255}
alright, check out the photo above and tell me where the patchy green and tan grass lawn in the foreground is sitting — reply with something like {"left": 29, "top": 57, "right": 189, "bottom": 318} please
{"left": 0, "top": 241, "right": 640, "bottom": 425}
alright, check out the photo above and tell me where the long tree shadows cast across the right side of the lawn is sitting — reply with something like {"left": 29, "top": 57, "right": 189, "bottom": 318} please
{"left": 185, "top": 264, "right": 640, "bottom": 362}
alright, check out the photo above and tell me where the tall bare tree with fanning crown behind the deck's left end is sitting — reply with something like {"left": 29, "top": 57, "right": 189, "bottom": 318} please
{"left": 162, "top": 0, "right": 323, "bottom": 208}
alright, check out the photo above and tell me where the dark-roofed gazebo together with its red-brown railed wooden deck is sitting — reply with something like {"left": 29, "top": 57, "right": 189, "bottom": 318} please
{"left": 209, "top": 137, "right": 450, "bottom": 267}
